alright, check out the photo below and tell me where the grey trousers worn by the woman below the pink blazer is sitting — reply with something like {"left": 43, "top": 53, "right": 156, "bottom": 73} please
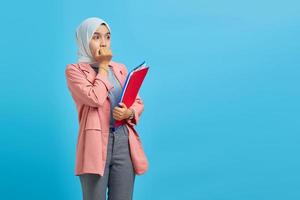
{"left": 79, "top": 125, "right": 135, "bottom": 200}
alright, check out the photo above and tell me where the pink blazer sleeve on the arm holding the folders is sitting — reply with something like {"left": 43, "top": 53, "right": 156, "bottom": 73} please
{"left": 122, "top": 65, "right": 144, "bottom": 126}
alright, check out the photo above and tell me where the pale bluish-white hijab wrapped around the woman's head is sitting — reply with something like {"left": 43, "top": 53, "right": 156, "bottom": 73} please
{"left": 76, "top": 17, "right": 110, "bottom": 63}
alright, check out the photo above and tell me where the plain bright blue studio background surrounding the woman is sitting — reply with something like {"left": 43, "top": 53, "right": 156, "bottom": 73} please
{"left": 0, "top": 0, "right": 300, "bottom": 200}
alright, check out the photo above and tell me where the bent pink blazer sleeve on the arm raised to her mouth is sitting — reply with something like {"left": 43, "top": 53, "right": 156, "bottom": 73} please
{"left": 65, "top": 64, "right": 113, "bottom": 107}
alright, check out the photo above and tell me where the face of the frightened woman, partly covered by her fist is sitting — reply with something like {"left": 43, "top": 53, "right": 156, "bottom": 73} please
{"left": 89, "top": 24, "right": 110, "bottom": 58}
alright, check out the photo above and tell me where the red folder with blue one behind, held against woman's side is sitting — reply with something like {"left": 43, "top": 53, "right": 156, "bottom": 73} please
{"left": 115, "top": 61, "right": 149, "bottom": 127}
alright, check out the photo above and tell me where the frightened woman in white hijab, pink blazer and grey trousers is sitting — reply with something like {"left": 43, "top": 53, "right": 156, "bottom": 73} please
{"left": 65, "top": 17, "right": 148, "bottom": 200}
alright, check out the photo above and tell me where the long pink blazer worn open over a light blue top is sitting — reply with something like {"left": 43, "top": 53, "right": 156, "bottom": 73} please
{"left": 65, "top": 61, "right": 148, "bottom": 176}
